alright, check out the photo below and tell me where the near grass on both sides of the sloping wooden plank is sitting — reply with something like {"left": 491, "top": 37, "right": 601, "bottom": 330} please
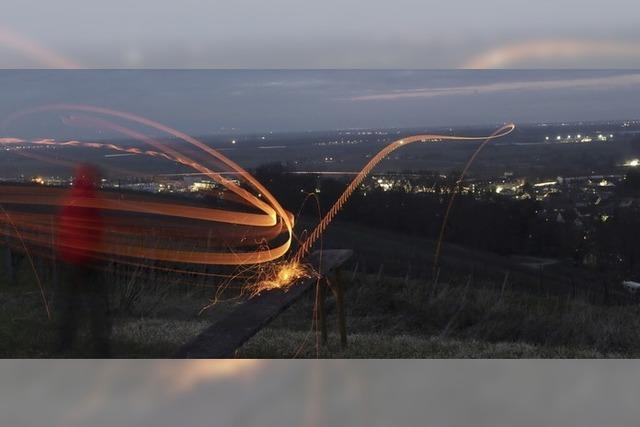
{"left": 5, "top": 268, "right": 640, "bottom": 358}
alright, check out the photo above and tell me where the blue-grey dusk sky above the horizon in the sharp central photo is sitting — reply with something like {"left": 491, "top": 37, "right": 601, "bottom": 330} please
{"left": 0, "top": 70, "right": 640, "bottom": 137}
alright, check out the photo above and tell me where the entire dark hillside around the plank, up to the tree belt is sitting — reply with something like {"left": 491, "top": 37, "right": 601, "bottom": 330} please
{"left": 0, "top": 216, "right": 640, "bottom": 358}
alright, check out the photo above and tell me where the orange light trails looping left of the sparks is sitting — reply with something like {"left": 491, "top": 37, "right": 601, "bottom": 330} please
{"left": 0, "top": 104, "right": 294, "bottom": 265}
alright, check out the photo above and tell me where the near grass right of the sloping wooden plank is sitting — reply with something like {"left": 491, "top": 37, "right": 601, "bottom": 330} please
{"left": 237, "top": 276, "right": 640, "bottom": 358}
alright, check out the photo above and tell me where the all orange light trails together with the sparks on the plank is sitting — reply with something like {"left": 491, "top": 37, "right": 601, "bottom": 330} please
{"left": 0, "top": 104, "right": 515, "bottom": 302}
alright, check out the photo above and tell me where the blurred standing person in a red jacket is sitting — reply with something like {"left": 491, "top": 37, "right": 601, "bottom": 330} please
{"left": 56, "top": 165, "right": 111, "bottom": 356}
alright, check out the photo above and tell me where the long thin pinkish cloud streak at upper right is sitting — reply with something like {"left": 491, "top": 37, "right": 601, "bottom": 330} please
{"left": 347, "top": 73, "right": 640, "bottom": 101}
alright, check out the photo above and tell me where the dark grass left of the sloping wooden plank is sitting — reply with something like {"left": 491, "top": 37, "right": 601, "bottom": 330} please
{"left": 0, "top": 265, "right": 234, "bottom": 358}
